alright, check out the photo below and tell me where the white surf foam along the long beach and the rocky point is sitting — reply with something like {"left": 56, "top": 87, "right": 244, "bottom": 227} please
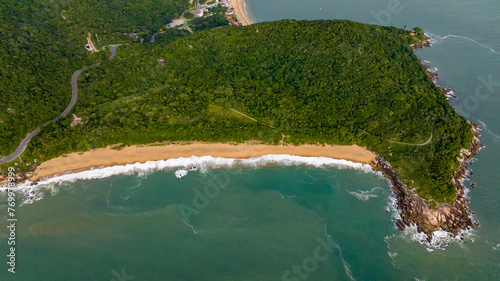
{"left": 0, "top": 154, "right": 476, "bottom": 250}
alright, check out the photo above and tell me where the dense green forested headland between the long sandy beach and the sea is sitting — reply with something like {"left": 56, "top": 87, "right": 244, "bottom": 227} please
{"left": 5, "top": 20, "right": 472, "bottom": 202}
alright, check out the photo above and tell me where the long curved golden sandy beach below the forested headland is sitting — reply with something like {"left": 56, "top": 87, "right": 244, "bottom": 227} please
{"left": 31, "top": 143, "right": 375, "bottom": 181}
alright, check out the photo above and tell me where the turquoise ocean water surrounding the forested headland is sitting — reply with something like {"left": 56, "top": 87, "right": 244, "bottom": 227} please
{"left": 0, "top": 0, "right": 500, "bottom": 281}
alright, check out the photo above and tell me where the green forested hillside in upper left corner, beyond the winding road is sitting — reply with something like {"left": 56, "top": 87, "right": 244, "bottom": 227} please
{"left": 0, "top": 0, "right": 188, "bottom": 155}
